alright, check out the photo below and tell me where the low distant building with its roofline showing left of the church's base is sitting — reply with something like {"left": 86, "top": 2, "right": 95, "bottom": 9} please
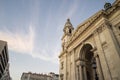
{"left": 21, "top": 72, "right": 59, "bottom": 80}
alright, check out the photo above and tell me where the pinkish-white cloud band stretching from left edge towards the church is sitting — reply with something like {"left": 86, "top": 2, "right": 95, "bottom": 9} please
{"left": 0, "top": 26, "right": 59, "bottom": 63}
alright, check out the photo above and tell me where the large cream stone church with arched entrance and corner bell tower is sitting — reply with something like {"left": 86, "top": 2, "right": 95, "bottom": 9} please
{"left": 59, "top": 0, "right": 120, "bottom": 80}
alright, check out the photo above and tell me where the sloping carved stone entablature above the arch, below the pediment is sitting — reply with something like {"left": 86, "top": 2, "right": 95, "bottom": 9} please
{"left": 67, "top": 18, "right": 111, "bottom": 52}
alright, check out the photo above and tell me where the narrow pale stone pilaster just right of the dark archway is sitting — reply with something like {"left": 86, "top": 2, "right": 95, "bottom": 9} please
{"left": 94, "top": 28, "right": 112, "bottom": 80}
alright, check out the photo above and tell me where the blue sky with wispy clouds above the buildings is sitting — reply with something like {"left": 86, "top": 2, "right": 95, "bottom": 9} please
{"left": 0, "top": 0, "right": 114, "bottom": 80}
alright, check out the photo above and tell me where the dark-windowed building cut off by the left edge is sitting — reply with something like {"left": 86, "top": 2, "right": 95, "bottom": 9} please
{"left": 0, "top": 40, "right": 10, "bottom": 80}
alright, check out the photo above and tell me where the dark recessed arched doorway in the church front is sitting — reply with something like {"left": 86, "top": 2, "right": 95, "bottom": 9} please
{"left": 80, "top": 44, "right": 99, "bottom": 80}
